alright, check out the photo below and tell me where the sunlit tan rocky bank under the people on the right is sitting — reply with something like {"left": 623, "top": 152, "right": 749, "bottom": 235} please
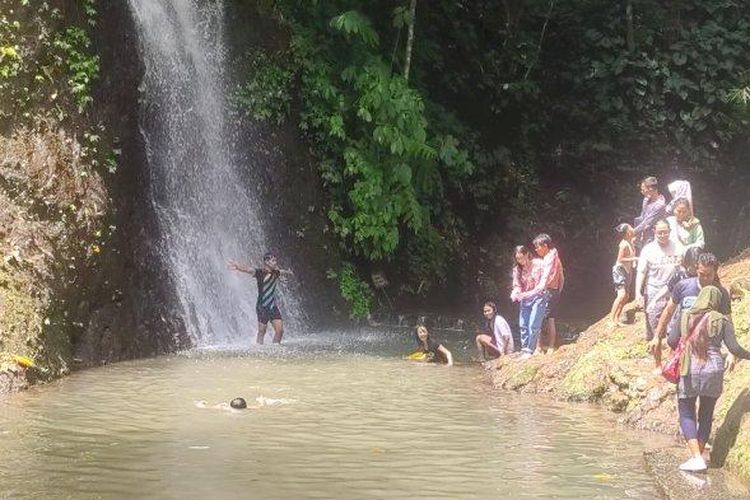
{"left": 493, "top": 254, "right": 750, "bottom": 482}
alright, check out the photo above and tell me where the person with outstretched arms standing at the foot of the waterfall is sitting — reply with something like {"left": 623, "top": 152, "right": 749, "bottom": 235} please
{"left": 229, "top": 252, "right": 294, "bottom": 344}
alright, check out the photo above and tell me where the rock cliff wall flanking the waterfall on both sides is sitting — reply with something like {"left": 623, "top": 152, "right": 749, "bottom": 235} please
{"left": 0, "top": 0, "right": 343, "bottom": 394}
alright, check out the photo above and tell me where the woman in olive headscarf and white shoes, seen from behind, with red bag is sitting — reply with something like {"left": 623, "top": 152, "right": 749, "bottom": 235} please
{"left": 667, "top": 286, "right": 750, "bottom": 472}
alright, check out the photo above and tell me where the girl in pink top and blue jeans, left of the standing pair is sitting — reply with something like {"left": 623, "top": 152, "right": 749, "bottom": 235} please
{"left": 510, "top": 245, "right": 547, "bottom": 355}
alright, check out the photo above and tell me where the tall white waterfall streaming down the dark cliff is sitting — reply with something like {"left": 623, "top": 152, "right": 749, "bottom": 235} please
{"left": 128, "top": 0, "right": 300, "bottom": 347}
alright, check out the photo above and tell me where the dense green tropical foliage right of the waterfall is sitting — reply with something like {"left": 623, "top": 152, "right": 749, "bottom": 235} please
{"left": 238, "top": 0, "right": 750, "bottom": 314}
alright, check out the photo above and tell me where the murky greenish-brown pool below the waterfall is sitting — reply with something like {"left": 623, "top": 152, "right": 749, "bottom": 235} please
{"left": 0, "top": 331, "right": 665, "bottom": 499}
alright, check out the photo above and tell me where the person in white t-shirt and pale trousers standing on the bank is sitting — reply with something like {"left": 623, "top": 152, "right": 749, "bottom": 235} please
{"left": 635, "top": 219, "right": 684, "bottom": 369}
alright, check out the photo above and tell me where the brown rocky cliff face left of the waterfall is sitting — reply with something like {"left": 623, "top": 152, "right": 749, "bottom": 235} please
{"left": 0, "top": 0, "right": 194, "bottom": 394}
